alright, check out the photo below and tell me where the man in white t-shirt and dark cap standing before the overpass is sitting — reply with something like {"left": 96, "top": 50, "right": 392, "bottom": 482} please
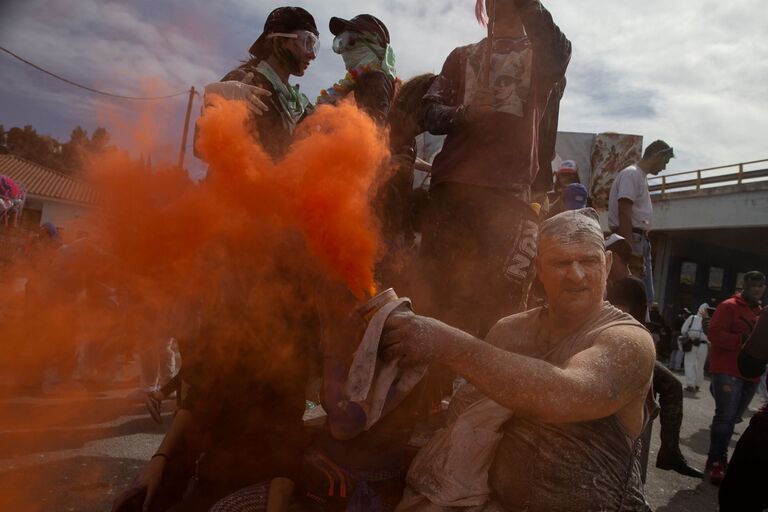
{"left": 608, "top": 140, "right": 675, "bottom": 305}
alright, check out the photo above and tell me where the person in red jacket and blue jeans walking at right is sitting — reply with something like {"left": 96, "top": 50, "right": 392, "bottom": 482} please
{"left": 707, "top": 271, "right": 765, "bottom": 485}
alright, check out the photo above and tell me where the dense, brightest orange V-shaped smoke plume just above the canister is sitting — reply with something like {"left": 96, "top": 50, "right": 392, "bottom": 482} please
{"left": 197, "top": 97, "right": 388, "bottom": 299}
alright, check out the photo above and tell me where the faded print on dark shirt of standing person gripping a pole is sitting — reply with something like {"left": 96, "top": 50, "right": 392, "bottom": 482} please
{"left": 463, "top": 38, "right": 533, "bottom": 117}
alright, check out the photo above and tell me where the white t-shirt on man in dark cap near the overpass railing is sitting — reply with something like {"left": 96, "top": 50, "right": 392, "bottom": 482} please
{"left": 608, "top": 165, "right": 653, "bottom": 231}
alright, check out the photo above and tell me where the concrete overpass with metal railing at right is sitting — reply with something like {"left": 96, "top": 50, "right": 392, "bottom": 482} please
{"left": 649, "top": 160, "right": 768, "bottom": 317}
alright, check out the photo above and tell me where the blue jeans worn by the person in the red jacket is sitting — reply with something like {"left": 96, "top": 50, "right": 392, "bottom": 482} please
{"left": 708, "top": 373, "right": 757, "bottom": 462}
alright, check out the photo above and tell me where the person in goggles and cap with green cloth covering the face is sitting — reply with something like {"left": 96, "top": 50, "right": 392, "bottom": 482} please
{"left": 317, "top": 14, "right": 397, "bottom": 124}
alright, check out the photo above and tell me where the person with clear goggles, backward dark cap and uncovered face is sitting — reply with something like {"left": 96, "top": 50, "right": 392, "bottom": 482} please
{"left": 204, "top": 7, "right": 320, "bottom": 161}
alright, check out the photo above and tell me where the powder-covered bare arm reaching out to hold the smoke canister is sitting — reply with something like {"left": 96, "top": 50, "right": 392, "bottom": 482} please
{"left": 384, "top": 313, "right": 655, "bottom": 423}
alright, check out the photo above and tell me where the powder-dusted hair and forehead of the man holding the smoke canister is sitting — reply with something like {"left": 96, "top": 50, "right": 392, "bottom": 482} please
{"left": 539, "top": 208, "right": 605, "bottom": 254}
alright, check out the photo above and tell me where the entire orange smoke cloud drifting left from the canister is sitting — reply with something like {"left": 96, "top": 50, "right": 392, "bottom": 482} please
{"left": 0, "top": 95, "right": 388, "bottom": 510}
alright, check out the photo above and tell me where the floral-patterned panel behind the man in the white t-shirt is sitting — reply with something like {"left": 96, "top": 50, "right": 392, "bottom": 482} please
{"left": 589, "top": 133, "right": 643, "bottom": 210}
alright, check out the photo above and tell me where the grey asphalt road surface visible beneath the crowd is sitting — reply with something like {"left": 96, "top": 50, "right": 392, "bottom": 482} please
{"left": 0, "top": 370, "right": 758, "bottom": 512}
